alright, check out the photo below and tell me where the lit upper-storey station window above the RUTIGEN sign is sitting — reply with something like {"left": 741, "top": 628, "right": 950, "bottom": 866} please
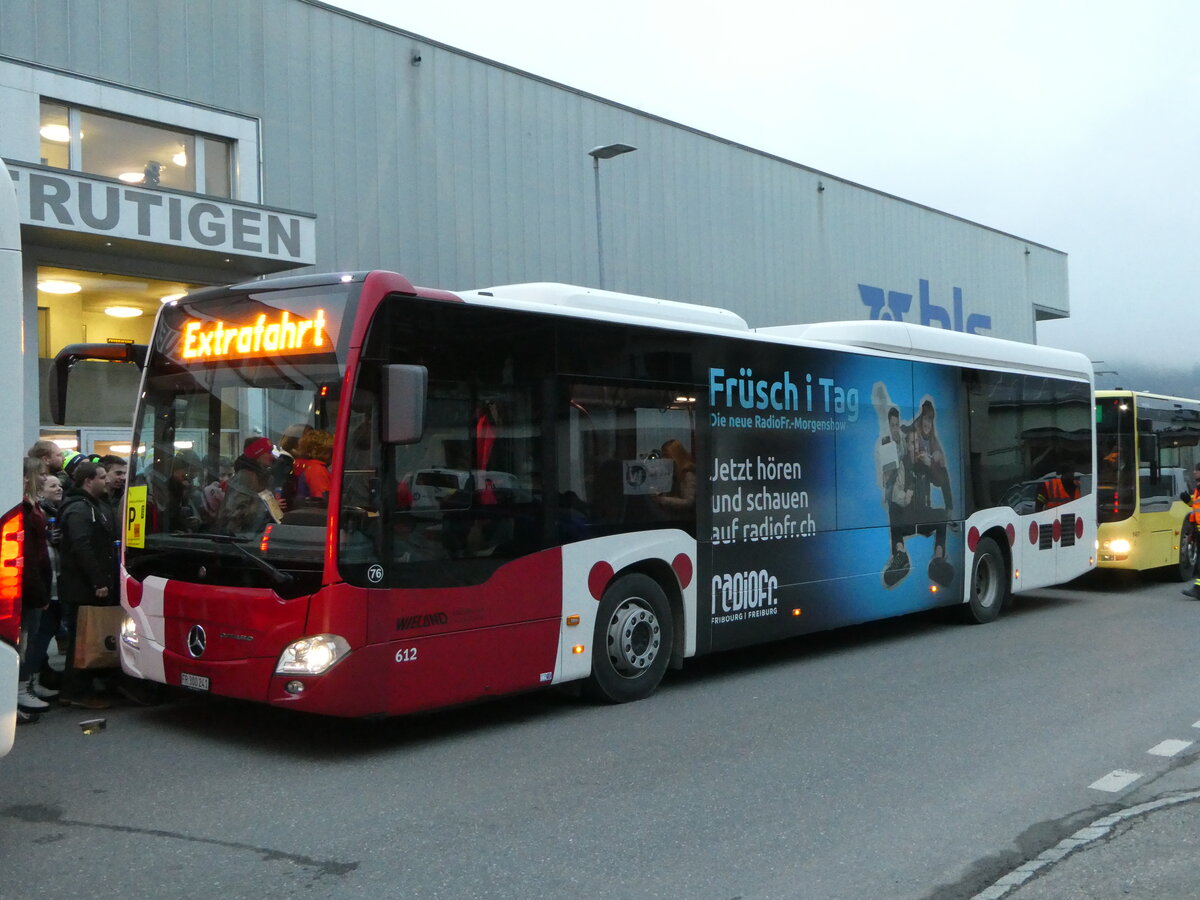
{"left": 38, "top": 100, "right": 233, "bottom": 197}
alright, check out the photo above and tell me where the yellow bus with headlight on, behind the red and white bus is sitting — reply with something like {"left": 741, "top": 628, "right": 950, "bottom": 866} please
{"left": 1096, "top": 390, "right": 1200, "bottom": 581}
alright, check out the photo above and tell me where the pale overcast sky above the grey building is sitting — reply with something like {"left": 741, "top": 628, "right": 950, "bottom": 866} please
{"left": 335, "top": 0, "right": 1200, "bottom": 367}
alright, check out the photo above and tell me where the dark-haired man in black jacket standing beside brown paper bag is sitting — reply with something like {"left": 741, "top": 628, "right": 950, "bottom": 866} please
{"left": 59, "top": 461, "right": 119, "bottom": 709}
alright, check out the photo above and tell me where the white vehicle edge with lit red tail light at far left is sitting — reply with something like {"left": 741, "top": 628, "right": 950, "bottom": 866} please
{"left": 0, "top": 160, "right": 25, "bottom": 756}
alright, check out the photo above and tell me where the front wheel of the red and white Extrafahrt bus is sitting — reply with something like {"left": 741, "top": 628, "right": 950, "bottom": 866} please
{"left": 586, "top": 572, "right": 674, "bottom": 703}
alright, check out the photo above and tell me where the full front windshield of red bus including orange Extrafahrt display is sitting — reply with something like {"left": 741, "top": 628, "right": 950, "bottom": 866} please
{"left": 126, "top": 286, "right": 350, "bottom": 595}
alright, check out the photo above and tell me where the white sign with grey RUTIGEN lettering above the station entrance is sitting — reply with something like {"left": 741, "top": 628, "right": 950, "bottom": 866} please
{"left": 10, "top": 163, "right": 316, "bottom": 265}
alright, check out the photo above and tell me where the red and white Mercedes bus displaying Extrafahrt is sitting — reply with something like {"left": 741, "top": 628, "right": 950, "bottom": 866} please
{"left": 59, "top": 271, "right": 1096, "bottom": 716}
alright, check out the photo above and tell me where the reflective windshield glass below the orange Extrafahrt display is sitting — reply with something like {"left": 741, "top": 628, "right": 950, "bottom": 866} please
{"left": 126, "top": 361, "right": 340, "bottom": 590}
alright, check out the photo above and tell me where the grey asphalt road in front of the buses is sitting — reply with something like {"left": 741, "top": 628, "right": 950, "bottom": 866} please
{"left": 0, "top": 574, "right": 1200, "bottom": 900}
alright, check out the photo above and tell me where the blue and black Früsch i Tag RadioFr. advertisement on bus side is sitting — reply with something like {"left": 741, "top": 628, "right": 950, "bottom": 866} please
{"left": 698, "top": 343, "right": 965, "bottom": 649}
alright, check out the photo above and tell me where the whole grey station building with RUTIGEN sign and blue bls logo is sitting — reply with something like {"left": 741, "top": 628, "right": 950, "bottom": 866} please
{"left": 0, "top": 0, "right": 1069, "bottom": 451}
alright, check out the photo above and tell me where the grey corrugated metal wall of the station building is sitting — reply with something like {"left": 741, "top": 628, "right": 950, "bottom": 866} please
{"left": 0, "top": 0, "right": 1068, "bottom": 340}
